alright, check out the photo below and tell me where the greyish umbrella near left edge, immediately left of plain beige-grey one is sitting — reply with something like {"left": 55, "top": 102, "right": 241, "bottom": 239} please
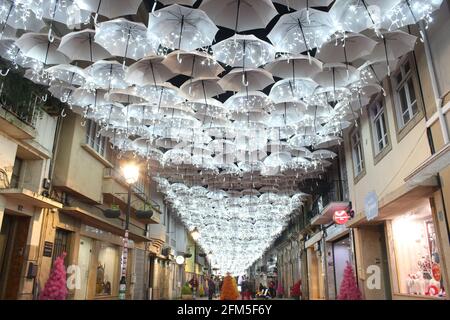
{"left": 16, "top": 32, "right": 70, "bottom": 65}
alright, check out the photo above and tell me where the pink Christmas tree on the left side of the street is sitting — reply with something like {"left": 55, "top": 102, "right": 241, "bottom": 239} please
{"left": 39, "top": 252, "right": 67, "bottom": 300}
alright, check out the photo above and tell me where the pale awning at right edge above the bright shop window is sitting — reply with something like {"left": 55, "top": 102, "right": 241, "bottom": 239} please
{"left": 405, "top": 143, "right": 450, "bottom": 186}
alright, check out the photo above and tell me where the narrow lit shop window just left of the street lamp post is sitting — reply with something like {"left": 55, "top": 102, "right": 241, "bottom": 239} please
{"left": 95, "top": 243, "right": 119, "bottom": 295}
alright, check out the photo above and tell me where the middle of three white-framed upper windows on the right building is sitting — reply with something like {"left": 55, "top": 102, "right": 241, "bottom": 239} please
{"left": 370, "top": 96, "right": 389, "bottom": 155}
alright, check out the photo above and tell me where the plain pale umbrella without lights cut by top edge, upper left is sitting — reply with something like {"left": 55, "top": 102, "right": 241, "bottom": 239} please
{"left": 75, "top": 0, "right": 142, "bottom": 22}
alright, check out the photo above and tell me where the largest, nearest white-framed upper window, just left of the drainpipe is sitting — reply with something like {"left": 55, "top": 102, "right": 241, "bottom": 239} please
{"left": 393, "top": 58, "right": 419, "bottom": 129}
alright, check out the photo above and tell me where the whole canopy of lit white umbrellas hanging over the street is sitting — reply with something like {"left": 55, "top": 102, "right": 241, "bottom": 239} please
{"left": 0, "top": 0, "right": 442, "bottom": 273}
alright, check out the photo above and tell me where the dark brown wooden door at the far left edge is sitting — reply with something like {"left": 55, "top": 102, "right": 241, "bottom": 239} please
{"left": 0, "top": 213, "right": 30, "bottom": 300}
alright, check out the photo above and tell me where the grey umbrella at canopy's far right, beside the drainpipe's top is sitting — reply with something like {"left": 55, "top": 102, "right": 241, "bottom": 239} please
{"left": 365, "top": 30, "right": 417, "bottom": 76}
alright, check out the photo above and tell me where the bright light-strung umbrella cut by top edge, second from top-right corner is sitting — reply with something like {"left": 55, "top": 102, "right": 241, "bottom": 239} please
{"left": 329, "top": 0, "right": 400, "bottom": 32}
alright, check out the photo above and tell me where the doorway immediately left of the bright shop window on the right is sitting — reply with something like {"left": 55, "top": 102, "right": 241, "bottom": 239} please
{"left": 359, "top": 224, "right": 391, "bottom": 300}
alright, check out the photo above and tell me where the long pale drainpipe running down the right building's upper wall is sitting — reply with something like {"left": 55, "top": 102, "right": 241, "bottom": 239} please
{"left": 419, "top": 21, "right": 449, "bottom": 144}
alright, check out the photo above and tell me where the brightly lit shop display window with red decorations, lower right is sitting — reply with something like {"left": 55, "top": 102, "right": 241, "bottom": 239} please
{"left": 392, "top": 205, "right": 445, "bottom": 297}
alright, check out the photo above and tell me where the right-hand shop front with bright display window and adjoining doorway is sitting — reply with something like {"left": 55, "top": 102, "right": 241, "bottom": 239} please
{"left": 347, "top": 186, "right": 447, "bottom": 299}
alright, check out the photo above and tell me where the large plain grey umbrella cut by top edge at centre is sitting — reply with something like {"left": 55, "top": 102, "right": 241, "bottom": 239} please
{"left": 200, "top": 0, "right": 278, "bottom": 33}
